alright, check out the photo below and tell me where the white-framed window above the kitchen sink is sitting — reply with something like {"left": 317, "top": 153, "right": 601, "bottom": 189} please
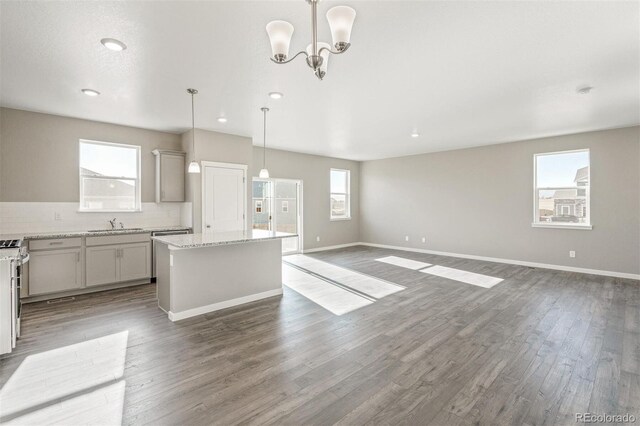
{"left": 80, "top": 140, "right": 141, "bottom": 212}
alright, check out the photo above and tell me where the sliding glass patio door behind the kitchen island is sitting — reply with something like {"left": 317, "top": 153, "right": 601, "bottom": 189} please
{"left": 251, "top": 178, "right": 302, "bottom": 254}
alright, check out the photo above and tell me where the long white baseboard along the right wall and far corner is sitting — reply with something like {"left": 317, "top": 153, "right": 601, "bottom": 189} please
{"left": 305, "top": 242, "right": 640, "bottom": 280}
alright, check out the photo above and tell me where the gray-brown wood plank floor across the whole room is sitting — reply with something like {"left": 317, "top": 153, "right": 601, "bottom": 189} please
{"left": 0, "top": 247, "right": 640, "bottom": 425}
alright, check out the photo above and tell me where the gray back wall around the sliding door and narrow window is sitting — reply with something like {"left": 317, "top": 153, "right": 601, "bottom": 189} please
{"left": 251, "top": 147, "right": 360, "bottom": 250}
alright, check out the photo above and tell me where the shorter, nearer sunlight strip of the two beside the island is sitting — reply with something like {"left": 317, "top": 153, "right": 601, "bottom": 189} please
{"left": 282, "top": 263, "right": 373, "bottom": 315}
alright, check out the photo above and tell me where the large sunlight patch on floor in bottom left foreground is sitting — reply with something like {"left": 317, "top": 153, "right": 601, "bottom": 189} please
{"left": 0, "top": 331, "right": 129, "bottom": 424}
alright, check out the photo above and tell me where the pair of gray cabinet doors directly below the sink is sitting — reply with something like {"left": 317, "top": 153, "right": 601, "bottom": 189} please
{"left": 87, "top": 243, "right": 151, "bottom": 287}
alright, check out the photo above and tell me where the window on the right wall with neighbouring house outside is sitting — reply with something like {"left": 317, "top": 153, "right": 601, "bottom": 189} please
{"left": 533, "top": 149, "right": 591, "bottom": 229}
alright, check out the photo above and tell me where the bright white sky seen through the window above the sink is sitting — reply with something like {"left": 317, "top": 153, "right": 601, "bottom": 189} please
{"left": 80, "top": 142, "right": 138, "bottom": 179}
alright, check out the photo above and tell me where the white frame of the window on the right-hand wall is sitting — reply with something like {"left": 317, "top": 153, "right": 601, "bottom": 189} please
{"left": 531, "top": 148, "right": 593, "bottom": 231}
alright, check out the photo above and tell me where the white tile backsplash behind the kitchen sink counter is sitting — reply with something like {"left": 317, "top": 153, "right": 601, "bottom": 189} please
{"left": 0, "top": 202, "right": 186, "bottom": 235}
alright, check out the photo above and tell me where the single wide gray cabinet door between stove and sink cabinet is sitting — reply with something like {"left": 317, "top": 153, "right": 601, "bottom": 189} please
{"left": 28, "top": 247, "right": 82, "bottom": 296}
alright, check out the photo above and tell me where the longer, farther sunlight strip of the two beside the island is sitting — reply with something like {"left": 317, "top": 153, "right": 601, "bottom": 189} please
{"left": 284, "top": 254, "right": 405, "bottom": 299}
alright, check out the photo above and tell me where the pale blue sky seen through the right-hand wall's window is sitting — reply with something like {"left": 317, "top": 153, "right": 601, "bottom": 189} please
{"left": 536, "top": 151, "right": 589, "bottom": 188}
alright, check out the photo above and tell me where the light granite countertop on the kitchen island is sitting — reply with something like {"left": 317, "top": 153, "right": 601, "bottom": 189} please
{"left": 153, "top": 229, "right": 298, "bottom": 249}
